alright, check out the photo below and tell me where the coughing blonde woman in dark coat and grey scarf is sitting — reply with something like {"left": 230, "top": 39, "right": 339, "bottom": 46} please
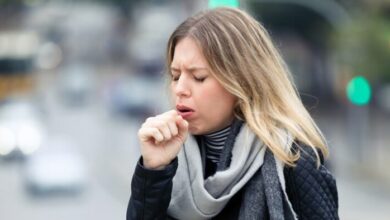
{"left": 127, "top": 8, "right": 338, "bottom": 219}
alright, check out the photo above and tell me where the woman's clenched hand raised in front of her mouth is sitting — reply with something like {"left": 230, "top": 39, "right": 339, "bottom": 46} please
{"left": 138, "top": 110, "right": 188, "bottom": 169}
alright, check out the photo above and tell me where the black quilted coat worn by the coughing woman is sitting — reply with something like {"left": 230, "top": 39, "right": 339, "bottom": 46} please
{"left": 127, "top": 145, "right": 339, "bottom": 220}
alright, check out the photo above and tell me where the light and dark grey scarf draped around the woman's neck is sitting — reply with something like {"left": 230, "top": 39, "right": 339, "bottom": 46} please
{"left": 168, "top": 124, "right": 296, "bottom": 220}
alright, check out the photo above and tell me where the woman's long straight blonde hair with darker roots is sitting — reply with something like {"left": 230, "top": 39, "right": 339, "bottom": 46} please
{"left": 166, "top": 7, "right": 328, "bottom": 165}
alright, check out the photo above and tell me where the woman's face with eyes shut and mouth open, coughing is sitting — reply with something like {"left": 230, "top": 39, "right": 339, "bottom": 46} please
{"left": 171, "top": 37, "right": 236, "bottom": 135}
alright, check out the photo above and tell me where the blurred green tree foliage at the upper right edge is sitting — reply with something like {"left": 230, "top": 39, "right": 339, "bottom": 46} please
{"left": 334, "top": 12, "right": 390, "bottom": 83}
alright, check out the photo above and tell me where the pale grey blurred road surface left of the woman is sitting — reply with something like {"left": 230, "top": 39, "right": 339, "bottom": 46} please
{"left": 0, "top": 70, "right": 139, "bottom": 220}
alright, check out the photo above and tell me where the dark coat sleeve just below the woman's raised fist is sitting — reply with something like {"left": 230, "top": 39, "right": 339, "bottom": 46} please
{"left": 126, "top": 158, "right": 178, "bottom": 220}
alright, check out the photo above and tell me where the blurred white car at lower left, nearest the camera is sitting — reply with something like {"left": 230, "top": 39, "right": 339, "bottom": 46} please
{"left": 25, "top": 137, "right": 86, "bottom": 195}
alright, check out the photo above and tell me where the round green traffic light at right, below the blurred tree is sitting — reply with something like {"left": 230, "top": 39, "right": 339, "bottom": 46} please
{"left": 347, "top": 76, "right": 371, "bottom": 106}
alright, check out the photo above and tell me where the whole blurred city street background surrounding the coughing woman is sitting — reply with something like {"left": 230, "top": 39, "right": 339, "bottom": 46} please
{"left": 0, "top": 0, "right": 390, "bottom": 220}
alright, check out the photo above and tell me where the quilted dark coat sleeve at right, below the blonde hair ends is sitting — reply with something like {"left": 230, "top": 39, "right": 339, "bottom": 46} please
{"left": 284, "top": 146, "right": 339, "bottom": 220}
